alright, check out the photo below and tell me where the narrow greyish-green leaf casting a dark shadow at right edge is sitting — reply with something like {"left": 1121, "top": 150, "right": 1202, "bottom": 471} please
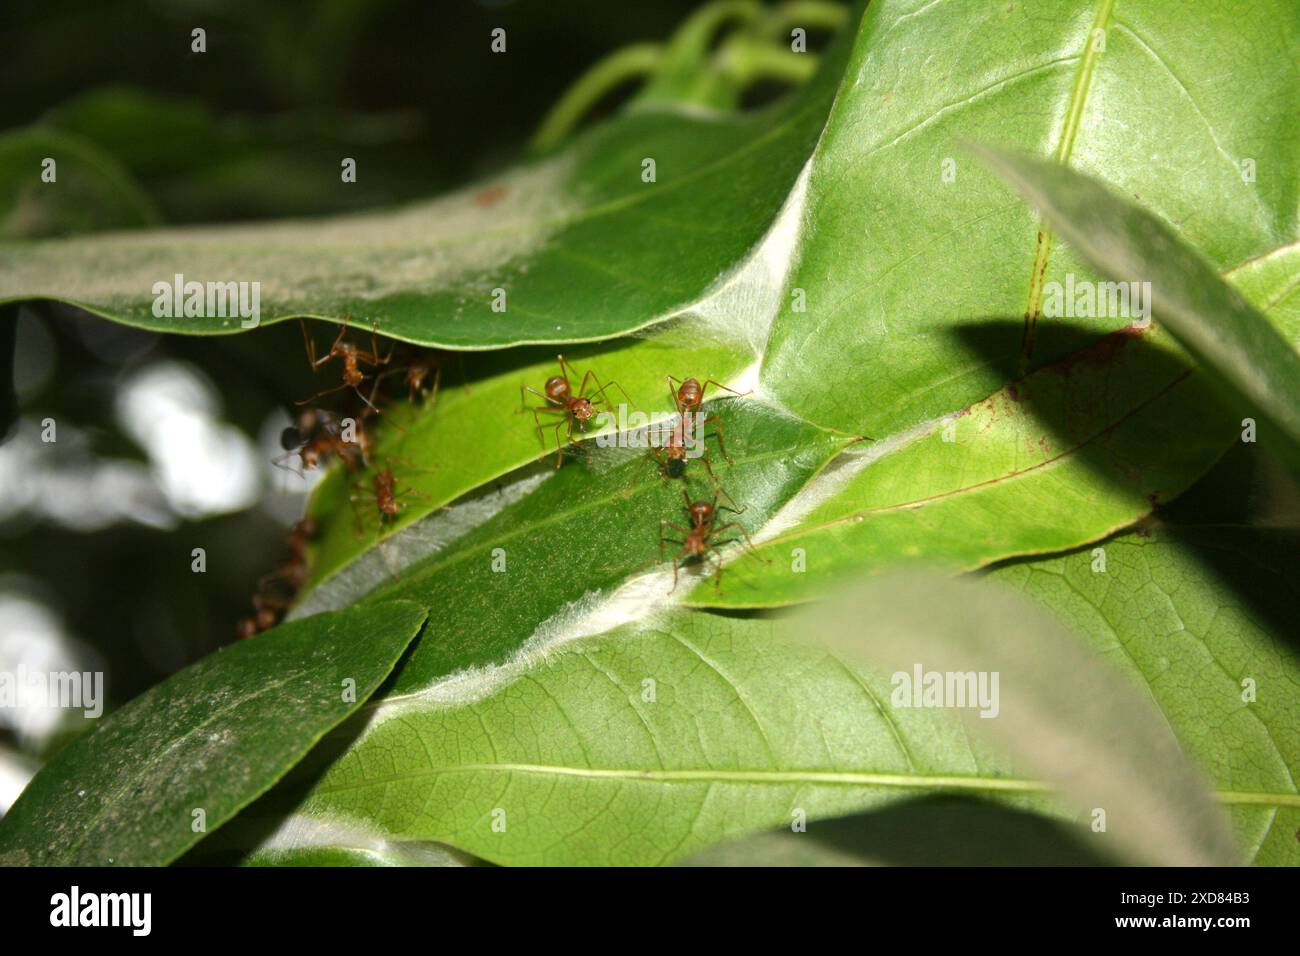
{"left": 976, "top": 148, "right": 1300, "bottom": 473}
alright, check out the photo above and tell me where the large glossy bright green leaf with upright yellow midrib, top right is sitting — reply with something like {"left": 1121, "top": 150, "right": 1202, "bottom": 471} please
{"left": 762, "top": 0, "right": 1300, "bottom": 436}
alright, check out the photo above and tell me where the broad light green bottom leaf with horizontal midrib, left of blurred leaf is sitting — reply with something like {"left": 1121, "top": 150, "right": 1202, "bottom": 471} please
{"left": 226, "top": 611, "right": 1041, "bottom": 865}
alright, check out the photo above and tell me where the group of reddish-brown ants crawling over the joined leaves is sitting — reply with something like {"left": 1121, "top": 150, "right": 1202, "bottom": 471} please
{"left": 237, "top": 320, "right": 754, "bottom": 637}
